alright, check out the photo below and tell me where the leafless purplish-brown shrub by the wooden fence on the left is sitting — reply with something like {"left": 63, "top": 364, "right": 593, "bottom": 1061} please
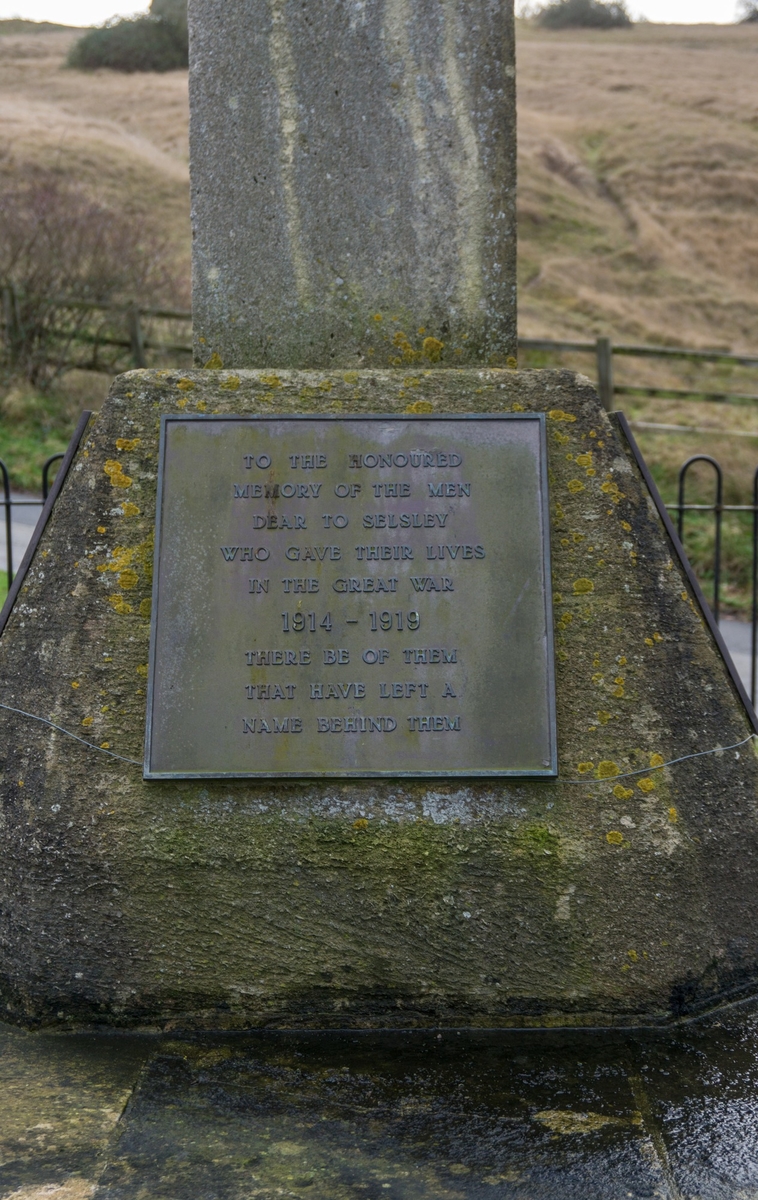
{"left": 0, "top": 173, "right": 174, "bottom": 388}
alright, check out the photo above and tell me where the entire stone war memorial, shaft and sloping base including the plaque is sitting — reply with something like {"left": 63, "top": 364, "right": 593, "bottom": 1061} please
{"left": 0, "top": 0, "right": 758, "bottom": 1030}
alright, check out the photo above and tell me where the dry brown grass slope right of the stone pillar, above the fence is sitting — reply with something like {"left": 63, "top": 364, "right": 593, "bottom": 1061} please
{"left": 518, "top": 23, "right": 758, "bottom": 352}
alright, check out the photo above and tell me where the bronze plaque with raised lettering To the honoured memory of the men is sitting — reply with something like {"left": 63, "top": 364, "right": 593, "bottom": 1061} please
{"left": 145, "top": 413, "right": 557, "bottom": 779}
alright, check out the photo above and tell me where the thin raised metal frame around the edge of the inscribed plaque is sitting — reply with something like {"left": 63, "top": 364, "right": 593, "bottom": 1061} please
{"left": 143, "top": 413, "right": 558, "bottom": 781}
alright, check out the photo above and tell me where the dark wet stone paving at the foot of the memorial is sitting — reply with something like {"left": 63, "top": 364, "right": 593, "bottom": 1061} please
{"left": 0, "top": 1004, "right": 758, "bottom": 1200}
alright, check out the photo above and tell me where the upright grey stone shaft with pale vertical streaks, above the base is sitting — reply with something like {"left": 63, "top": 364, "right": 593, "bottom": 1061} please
{"left": 190, "top": 0, "right": 516, "bottom": 367}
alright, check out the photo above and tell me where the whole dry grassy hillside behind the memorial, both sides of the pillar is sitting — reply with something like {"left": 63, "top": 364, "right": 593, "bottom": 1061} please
{"left": 0, "top": 22, "right": 758, "bottom": 609}
